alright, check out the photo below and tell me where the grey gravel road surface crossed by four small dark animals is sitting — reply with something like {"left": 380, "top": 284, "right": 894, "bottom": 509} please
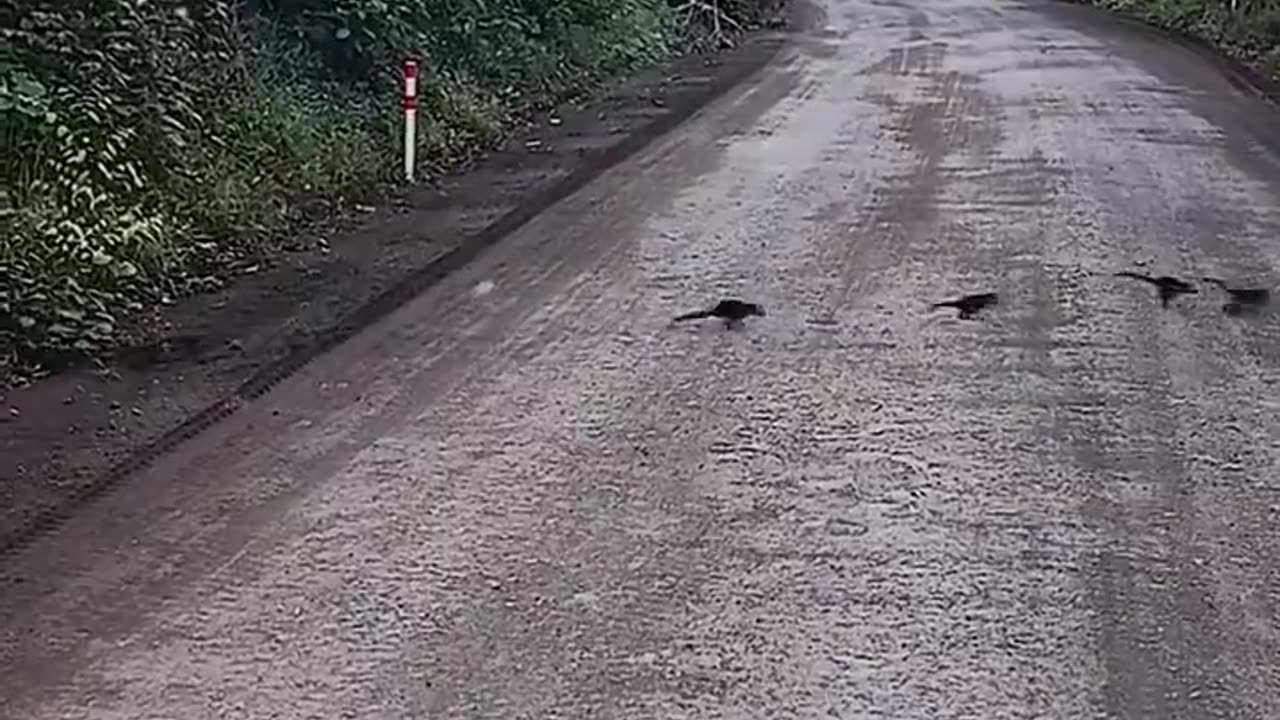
{"left": 0, "top": 0, "right": 1280, "bottom": 720}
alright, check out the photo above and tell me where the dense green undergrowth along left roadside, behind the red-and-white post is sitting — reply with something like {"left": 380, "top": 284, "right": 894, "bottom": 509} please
{"left": 0, "top": 0, "right": 760, "bottom": 386}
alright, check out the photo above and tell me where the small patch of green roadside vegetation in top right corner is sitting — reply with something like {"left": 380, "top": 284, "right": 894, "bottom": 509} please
{"left": 1085, "top": 0, "right": 1280, "bottom": 82}
